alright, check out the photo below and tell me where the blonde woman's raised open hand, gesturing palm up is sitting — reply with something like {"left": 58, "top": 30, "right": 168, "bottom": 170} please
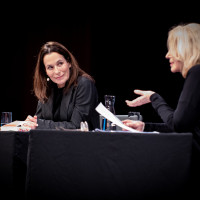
{"left": 125, "top": 90, "right": 155, "bottom": 107}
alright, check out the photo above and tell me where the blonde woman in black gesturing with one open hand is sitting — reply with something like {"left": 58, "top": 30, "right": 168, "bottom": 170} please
{"left": 124, "top": 23, "right": 200, "bottom": 192}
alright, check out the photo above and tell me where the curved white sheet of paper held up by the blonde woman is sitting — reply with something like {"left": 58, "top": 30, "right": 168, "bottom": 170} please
{"left": 96, "top": 103, "right": 140, "bottom": 132}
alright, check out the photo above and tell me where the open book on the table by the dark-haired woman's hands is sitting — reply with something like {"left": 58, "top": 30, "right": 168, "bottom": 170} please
{"left": 1, "top": 120, "right": 31, "bottom": 132}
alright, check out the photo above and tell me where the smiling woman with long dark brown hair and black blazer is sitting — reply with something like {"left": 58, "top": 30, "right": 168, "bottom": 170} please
{"left": 26, "top": 42, "right": 99, "bottom": 130}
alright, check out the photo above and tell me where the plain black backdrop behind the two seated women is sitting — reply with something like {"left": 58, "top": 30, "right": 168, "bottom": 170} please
{"left": 0, "top": 2, "right": 200, "bottom": 122}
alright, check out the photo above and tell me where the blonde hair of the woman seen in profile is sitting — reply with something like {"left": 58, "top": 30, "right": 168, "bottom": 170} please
{"left": 167, "top": 23, "right": 200, "bottom": 78}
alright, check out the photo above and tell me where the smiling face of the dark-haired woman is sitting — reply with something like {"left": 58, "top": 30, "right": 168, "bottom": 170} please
{"left": 43, "top": 52, "right": 71, "bottom": 88}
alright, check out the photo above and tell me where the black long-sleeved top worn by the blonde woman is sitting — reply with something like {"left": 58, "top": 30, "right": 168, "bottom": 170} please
{"left": 150, "top": 65, "right": 200, "bottom": 147}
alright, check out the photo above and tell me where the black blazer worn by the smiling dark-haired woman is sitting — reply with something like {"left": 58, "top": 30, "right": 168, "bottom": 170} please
{"left": 36, "top": 76, "right": 99, "bottom": 130}
